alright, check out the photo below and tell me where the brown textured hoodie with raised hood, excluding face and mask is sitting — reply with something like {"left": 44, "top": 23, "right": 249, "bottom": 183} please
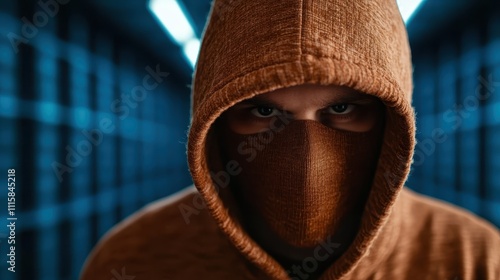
{"left": 81, "top": 0, "right": 500, "bottom": 280}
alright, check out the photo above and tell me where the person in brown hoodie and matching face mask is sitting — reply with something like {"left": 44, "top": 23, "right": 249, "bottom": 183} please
{"left": 81, "top": 0, "right": 500, "bottom": 280}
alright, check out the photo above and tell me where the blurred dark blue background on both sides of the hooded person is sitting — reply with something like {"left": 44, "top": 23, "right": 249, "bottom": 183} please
{"left": 0, "top": 0, "right": 500, "bottom": 280}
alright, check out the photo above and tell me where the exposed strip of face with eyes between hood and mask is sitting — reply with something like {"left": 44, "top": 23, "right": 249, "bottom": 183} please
{"left": 223, "top": 85, "right": 385, "bottom": 134}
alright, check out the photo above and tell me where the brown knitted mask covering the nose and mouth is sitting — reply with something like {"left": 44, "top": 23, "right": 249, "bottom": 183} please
{"left": 221, "top": 120, "right": 382, "bottom": 248}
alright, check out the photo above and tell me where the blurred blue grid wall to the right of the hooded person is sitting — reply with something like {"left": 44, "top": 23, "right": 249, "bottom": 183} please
{"left": 408, "top": 14, "right": 500, "bottom": 227}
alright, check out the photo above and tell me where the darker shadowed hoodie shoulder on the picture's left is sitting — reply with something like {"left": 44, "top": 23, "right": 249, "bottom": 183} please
{"left": 81, "top": 187, "right": 248, "bottom": 279}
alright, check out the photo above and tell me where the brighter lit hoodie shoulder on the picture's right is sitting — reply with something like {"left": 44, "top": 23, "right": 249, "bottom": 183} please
{"left": 399, "top": 189, "right": 500, "bottom": 279}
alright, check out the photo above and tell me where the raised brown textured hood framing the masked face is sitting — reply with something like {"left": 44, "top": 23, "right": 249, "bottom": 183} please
{"left": 188, "top": 0, "right": 415, "bottom": 279}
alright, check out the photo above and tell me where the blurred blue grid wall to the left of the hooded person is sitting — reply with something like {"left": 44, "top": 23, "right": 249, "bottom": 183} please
{"left": 0, "top": 1, "right": 191, "bottom": 280}
